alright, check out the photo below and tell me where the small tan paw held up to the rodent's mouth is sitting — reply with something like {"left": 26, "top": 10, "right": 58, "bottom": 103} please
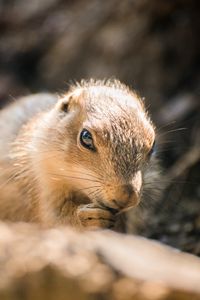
{"left": 77, "top": 204, "right": 115, "bottom": 229}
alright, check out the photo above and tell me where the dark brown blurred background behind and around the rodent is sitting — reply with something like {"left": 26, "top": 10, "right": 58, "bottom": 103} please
{"left": 0, "top": 0, "right": 200, "bottom": 255}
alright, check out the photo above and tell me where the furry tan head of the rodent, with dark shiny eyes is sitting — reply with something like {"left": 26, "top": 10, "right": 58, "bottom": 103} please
{"left": 38, "top": 80, "right": 155, "bottom": 211}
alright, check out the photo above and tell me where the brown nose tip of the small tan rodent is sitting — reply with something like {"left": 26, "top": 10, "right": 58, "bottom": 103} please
{"left": 112, "top": 184, "right": 139, "bottom": 209}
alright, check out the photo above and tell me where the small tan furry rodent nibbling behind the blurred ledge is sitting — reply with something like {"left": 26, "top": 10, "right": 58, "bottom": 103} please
{"left": 0, "top": 80, "right": 155, "bottom": 229}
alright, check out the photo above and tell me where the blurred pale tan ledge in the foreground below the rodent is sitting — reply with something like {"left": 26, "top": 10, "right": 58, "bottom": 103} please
{"left": 0, "top": 223, "right": 200, "bottom": 300}
